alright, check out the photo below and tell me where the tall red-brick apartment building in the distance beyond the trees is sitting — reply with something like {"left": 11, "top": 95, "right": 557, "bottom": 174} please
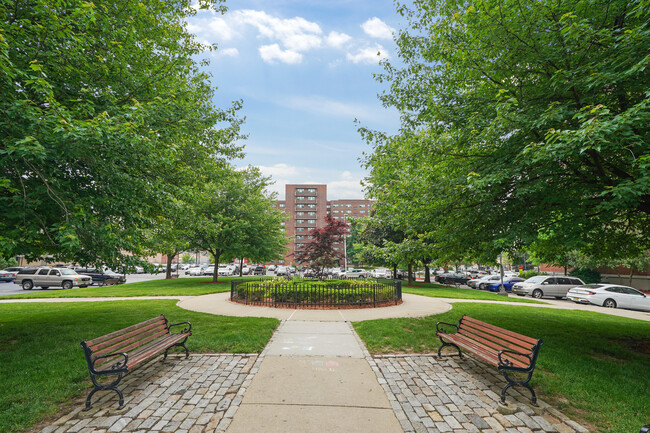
{"left": 272, "top": 184, "right": 372, "bottom": 265}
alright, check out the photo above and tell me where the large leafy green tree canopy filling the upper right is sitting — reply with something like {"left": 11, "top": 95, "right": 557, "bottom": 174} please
{"left": 362, "top": 0, "right": 650, "bottom": 263}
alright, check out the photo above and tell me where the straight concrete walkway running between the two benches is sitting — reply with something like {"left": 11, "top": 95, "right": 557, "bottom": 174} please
{"left": 226, "top": 321, "right": 402, "bottom": 433}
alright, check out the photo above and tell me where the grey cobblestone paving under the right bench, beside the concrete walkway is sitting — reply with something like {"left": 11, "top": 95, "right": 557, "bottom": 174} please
{"left": 366, "top": 355, "right": 588, "bottom": 433}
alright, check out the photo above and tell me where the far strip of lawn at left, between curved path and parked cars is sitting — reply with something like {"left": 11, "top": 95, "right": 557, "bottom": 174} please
{"left": 0, "top": 277, "right": 238, "bottom": 299}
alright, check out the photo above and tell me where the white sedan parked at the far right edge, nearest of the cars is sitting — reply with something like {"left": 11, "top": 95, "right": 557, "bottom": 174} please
{"left": 567, "top": 284, "right": 650, "bottom": 311}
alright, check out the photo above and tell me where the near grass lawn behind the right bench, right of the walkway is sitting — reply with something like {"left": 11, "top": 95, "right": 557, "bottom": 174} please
{"left": 354, "top": 303, "right": 650, "bottom": 433}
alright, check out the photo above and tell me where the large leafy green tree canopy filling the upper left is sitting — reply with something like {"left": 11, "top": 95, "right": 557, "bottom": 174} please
{"left": 0, "top": 0, "right": 240, "bottom": 267}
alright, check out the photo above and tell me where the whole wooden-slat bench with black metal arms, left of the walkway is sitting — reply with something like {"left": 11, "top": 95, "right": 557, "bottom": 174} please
{"left": 81, "top": 314, "right": 192, "bottom": 410}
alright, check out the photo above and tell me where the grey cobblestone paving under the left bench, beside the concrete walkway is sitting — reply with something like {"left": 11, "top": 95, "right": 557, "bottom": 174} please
{"left": 38, "top": 354, "right": 260, "bottom": 433}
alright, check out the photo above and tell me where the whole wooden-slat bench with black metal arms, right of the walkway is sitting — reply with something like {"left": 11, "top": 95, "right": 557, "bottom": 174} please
{"left": 436, "top": 315, "right": 542, "bottom": 406}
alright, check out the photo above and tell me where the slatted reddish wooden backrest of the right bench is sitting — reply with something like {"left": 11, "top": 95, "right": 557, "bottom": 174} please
{"left": 458, "top": 316, "right": 540, "bottom": 365}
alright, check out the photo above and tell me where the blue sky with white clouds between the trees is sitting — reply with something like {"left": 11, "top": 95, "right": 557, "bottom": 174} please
{"left": 188, "top": 0, "right": 399, "bottom": 199}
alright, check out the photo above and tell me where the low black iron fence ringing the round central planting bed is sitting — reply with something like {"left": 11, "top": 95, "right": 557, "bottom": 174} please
{"left": 230, "top": 280, "right": 402, "bottom": 309}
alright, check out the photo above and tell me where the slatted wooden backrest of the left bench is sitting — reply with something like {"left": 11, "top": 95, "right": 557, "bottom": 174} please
{"left": 81, "top": 314, "right": 169, "bottom": 368}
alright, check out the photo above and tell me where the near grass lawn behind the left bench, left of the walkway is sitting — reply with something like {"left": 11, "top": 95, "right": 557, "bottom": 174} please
{"left": 0, "top": 300, "right": 279, "bottom": 433}
